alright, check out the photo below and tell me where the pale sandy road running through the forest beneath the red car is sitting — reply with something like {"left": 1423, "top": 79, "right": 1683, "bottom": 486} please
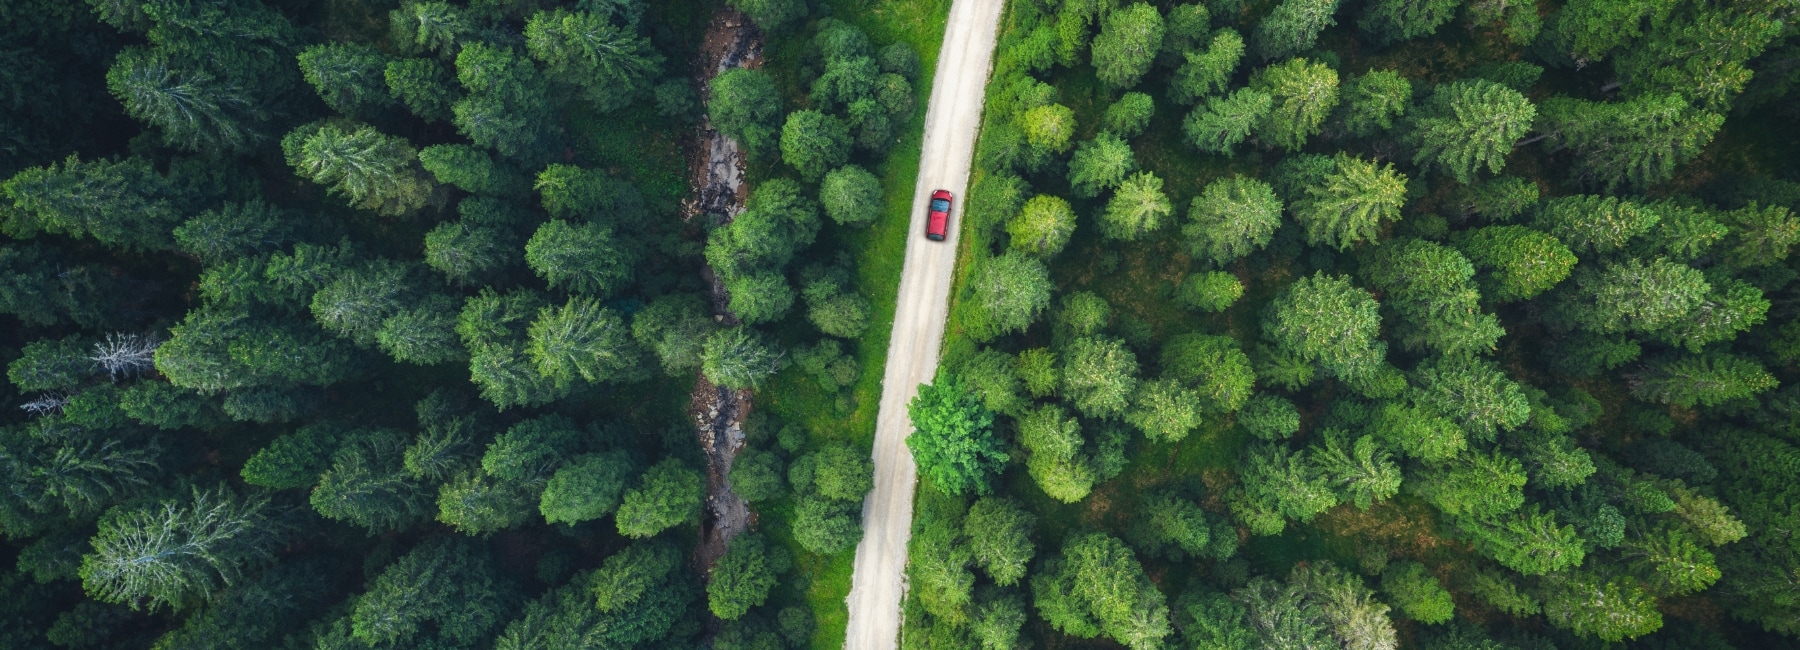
{"left": 844, "top": 0, "right": 1004, "bottom": 650}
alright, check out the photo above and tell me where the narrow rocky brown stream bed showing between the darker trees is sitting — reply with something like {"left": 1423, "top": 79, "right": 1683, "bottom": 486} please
{"left": 684, "top": 7, "right": 763, "bottom": 574}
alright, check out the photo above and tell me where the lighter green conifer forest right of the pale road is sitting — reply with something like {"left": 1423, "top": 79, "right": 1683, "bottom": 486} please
{"left": 902, "top": 0, "right": 1800, "bottom": 650}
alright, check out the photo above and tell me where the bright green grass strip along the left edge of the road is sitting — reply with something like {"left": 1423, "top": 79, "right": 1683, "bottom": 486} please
{"left": 734, "top": 0, "right": 950, "bottom": 650}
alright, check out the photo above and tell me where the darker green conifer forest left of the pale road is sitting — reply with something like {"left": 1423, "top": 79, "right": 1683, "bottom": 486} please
{"left": 0, "top": 0, "right": 947, "bottom": 650}
